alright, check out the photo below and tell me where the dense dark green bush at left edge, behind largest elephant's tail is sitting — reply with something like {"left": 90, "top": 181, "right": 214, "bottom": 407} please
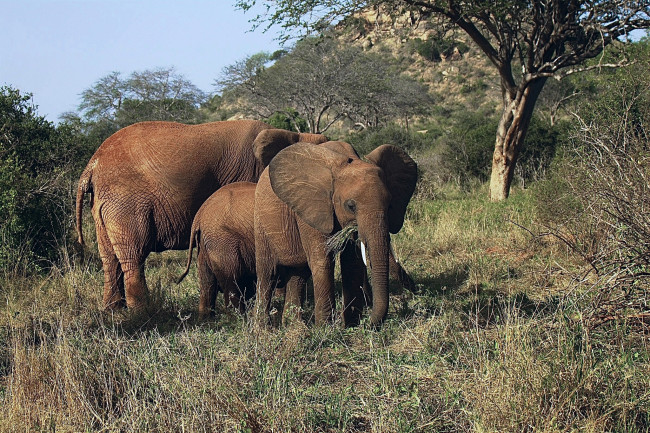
{"left": 0, "top": 87, "right": 89, "bottom": 272}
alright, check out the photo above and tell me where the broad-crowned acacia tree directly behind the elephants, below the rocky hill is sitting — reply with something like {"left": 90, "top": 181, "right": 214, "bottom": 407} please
{"left": 216, "top": 37, "right": 428, "bottom": 133}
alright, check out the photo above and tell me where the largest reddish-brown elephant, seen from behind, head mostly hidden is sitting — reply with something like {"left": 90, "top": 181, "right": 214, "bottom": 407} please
{"left": 76, "top": 120, "right": 327, "bottom": 308}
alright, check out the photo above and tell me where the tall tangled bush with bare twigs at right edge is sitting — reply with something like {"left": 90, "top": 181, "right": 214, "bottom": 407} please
{"left": 539, "top": 40, "right": 650, "bottom": 321}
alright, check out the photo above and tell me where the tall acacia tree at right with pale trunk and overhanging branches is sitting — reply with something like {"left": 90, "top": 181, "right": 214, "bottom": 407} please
{"left": 236, "top": 0, "right": 650, "bottom": 201}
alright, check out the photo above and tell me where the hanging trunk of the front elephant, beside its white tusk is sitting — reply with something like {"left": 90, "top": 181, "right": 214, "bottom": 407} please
{"left": 358, "top": 213, "right": 390, "bottom": 326}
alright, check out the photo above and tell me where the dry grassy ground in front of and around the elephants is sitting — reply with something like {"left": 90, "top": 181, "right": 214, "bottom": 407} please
{"left": 0, "top": 188, "right": 650, "bottom": 432}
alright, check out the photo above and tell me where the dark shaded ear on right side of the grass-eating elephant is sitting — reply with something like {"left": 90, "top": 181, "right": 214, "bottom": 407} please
{"left": 366, "top": 144, "right": 418, "bottom": 233}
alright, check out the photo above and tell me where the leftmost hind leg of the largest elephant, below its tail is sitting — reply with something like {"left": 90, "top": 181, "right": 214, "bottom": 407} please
{"left": 95, "top": 215, "right": 126, "bottom": 310}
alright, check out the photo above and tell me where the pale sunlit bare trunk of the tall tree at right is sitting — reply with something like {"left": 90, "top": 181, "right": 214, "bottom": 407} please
{"left": 490, "top": 78, "right": 546, "bottom": 201}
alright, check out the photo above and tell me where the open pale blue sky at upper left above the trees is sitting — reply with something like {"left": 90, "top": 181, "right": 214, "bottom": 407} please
{"left": 0, "top": 0, "right": 279, "bottom": 121}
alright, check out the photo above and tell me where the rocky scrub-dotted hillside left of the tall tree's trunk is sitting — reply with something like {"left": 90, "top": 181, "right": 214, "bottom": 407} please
{"left": 337, "top": 12, "right": 501, "bottom": 121}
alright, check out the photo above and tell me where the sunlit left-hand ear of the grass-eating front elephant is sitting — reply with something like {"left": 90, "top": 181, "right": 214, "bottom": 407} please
{"left": 269, "top": 143, "right": 348, "bottom": 234}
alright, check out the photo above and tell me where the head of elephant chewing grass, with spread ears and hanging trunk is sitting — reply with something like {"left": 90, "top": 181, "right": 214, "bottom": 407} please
{"left": 269, "top": 142, "right": 417, "bottom": 325}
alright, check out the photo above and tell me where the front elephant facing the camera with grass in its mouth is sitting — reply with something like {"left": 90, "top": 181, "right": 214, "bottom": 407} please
{"left": 254, "top": 142, "right": 417, "bottom": 326}
